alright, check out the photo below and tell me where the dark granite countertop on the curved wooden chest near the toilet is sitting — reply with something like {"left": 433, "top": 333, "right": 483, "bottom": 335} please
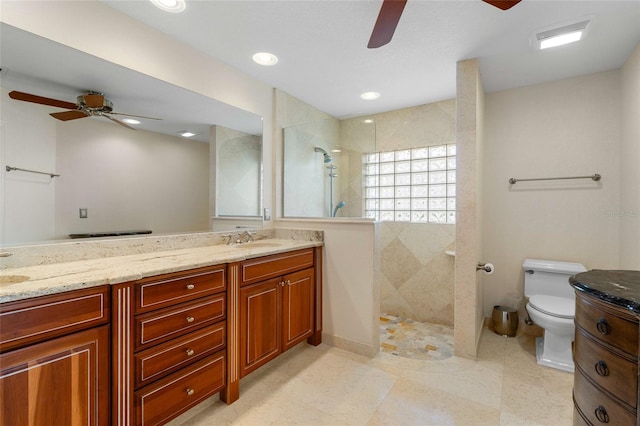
{"left": 569, "top": 269, "right": 640, "bottom": 315}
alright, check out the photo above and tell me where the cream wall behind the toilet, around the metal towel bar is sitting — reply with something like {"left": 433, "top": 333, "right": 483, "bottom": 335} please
{"left": 483, "top": 71, "right": 624, "bottom": 316}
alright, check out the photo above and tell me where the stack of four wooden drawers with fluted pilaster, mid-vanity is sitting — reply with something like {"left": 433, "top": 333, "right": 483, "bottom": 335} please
{"left": 113, "top": 265, "right": 227, "bottom": 425}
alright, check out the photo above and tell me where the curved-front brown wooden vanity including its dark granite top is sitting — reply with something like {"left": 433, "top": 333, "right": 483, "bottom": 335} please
{"left": 570, "top": 270, "right": 640, "bottom": 426}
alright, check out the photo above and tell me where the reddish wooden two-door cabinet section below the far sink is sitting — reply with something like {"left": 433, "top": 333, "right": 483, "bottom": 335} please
{"left": 239, "top": 249, "right": 320, "bottom": 377}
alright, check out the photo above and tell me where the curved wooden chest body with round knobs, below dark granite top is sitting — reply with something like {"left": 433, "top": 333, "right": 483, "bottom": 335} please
{"left": 573, "top": 291, "right": 640, "bottom": 426}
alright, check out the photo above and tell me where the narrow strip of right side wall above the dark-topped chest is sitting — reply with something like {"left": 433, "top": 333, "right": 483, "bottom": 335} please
{"left": 615, "top": 44, "right": 640, "bottom": 270}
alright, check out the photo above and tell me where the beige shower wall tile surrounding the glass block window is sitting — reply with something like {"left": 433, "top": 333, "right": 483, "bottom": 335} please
{"left": 340, "top": 99, "right": 456, "bottom": 325}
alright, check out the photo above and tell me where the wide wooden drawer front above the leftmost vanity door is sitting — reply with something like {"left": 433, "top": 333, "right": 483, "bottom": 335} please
{"left": 0, "top": 286, "right": 109, "bottom": 352}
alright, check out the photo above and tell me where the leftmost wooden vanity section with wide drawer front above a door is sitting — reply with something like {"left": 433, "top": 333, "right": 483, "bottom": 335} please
{"left": 0, "top": 286, "right": 111, "bottom": 426}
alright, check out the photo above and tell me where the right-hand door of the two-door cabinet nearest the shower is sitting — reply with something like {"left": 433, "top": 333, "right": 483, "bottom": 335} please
{"left": 282, "top": 269, "right": 315, "bottom": 351}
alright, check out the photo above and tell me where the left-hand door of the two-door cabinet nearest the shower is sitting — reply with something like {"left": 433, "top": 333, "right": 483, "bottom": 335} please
{"left": 240, "top": 278, "right": 282, "bottom": 377}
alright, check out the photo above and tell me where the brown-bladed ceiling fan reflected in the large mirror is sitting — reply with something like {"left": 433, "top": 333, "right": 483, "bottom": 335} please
{"left": 9, "top": 90, "right": 160, "bottom": 130}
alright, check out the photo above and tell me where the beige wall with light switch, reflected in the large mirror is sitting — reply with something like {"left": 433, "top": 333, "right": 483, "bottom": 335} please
{"left": 54, "top": 114, "right": 209, "bottom": 238}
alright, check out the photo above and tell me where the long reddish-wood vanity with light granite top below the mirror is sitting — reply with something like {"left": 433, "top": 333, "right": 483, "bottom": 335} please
{"left": 0, "top": 239, "right": 322, "bottom": 425}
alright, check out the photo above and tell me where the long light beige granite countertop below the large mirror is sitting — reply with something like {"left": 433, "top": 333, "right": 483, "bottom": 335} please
{"left": 0, "top": 239, "right": 322, "bottom": 303}
